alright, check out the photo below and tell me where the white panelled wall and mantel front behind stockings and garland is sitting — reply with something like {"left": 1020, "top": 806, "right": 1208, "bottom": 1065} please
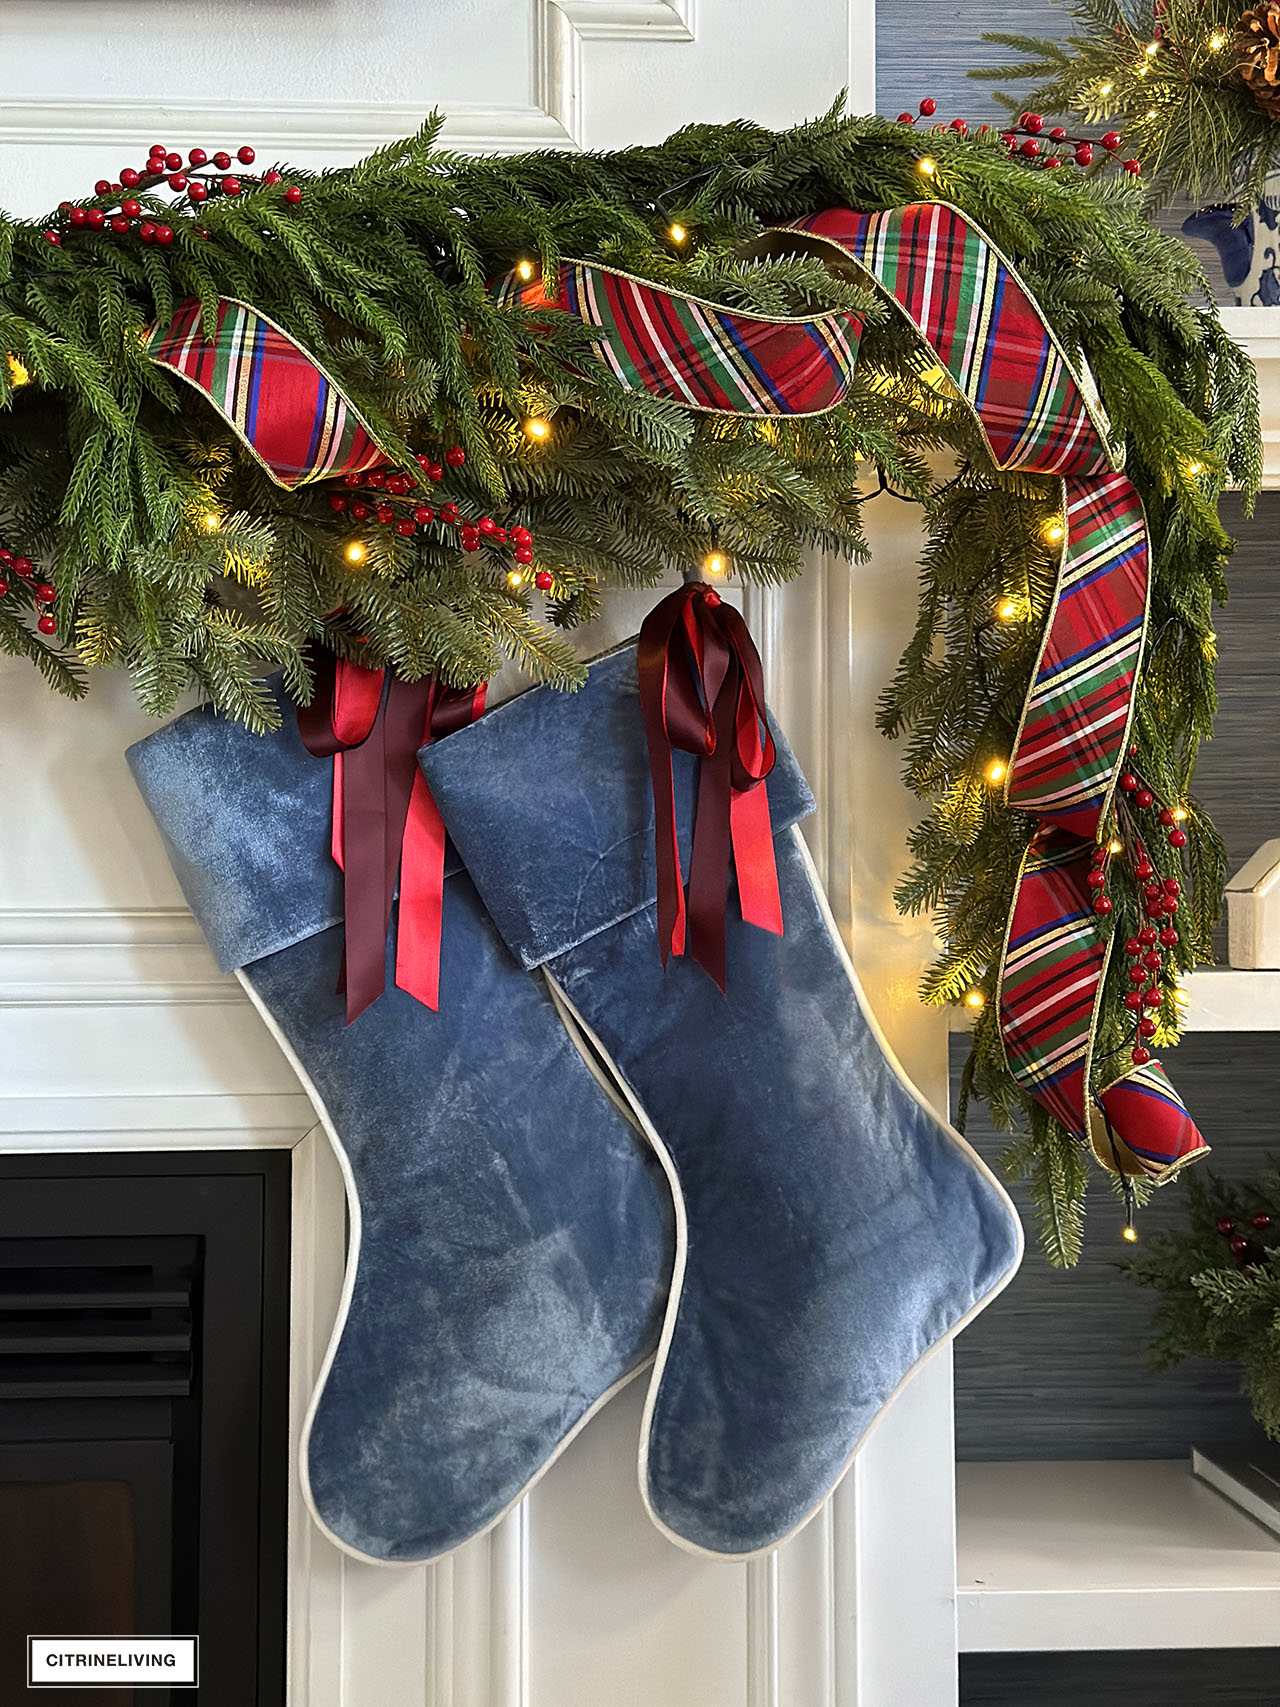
{"left": 0, "top": 0, "right": 954, "bottom": 1707}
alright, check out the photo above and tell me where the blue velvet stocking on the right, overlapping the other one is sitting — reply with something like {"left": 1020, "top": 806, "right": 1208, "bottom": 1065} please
{"left": 420, "top": 647, "right": 1022, "bottom": 1557}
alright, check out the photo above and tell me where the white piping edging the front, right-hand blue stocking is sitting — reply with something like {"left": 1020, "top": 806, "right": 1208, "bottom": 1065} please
{"left": 543, "top": 824, "right": 1024, "bottom": 1564}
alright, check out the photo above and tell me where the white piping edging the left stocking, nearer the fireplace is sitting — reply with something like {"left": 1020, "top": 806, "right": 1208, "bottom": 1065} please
{"left": 236, "top": 966, "right": 654, "bottom": 1570}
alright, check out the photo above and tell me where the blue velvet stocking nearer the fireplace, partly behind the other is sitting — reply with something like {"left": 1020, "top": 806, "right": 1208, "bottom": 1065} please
{"left": 130, "top": 689, "right": 672, "bottom": 1562}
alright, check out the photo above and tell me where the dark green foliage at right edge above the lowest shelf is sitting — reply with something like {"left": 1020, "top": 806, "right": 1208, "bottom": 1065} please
{"left": 1123, "top": 1162, "right": 1280, "bottom": 1441}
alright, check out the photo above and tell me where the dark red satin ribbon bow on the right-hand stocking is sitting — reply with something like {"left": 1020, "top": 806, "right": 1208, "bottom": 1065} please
{"left": 637, "top": 582, "right": 782, "bottom": 990}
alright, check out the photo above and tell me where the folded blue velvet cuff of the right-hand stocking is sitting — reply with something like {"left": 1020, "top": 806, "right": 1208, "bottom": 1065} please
{"left": 418, "top": 645, "right": 814, "bottom": 968}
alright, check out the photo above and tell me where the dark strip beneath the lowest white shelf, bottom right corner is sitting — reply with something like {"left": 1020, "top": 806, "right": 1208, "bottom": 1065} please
{"left": 969, "top": 1647, "right": 1280, "bottom": 1707}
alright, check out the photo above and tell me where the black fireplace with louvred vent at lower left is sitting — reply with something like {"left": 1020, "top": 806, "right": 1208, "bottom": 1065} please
{"left": 0, "top": 1151, "right": 290, "bottom": 1707}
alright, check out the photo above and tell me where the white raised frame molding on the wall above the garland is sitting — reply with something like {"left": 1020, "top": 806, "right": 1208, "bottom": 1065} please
{"left": 0, "top": 0, "right": 695, "bottom": 155}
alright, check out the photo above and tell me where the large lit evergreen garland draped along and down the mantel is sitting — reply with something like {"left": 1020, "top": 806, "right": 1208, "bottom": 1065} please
{"left": 0, "top": 106, "right": 1261, "bottom": 1261}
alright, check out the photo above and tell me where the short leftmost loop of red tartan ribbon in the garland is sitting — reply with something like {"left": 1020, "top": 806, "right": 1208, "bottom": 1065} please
{"left": 145, "top": 297, "right": 387, "bottom": 490}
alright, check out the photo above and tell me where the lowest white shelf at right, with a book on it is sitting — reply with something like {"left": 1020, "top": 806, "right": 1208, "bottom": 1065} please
{"left": 956, "top": 1459, "right": 1280, "bottom": 1654}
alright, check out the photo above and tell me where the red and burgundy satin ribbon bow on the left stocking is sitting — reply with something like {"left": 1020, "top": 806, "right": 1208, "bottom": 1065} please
{"left": 297, "top": 654, "right": 485, "bottom": 1026}
